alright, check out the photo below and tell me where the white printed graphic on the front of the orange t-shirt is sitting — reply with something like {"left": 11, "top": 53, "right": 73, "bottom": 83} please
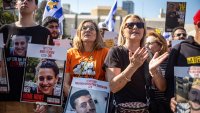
{"left": 73, "top": 61, "right": 96, "bottom": 75}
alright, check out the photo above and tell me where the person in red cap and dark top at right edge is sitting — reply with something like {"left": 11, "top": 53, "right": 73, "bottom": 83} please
{"left": 166, "top": 10, "right": 200, "bottom": 112}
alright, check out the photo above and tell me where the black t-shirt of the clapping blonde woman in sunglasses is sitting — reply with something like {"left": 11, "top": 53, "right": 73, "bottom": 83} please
{"left": 103, "top": 46, "right": 146, "bottom": 103}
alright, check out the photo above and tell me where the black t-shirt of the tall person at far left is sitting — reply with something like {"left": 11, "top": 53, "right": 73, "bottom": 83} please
{"left": 0, "top": 23, "right": 50, "bottom": 101}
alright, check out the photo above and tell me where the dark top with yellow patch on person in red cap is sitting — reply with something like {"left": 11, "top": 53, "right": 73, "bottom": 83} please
{"left": 165, "top": 37, "right": 200, "bottom": 99}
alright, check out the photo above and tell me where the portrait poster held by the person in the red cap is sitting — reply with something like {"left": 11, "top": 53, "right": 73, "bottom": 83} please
{"left": 174, "top": 66, "right": 200, "bottom": 113}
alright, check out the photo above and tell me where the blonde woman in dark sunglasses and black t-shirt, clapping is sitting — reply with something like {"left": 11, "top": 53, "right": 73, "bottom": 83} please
{"left": 104, "top": 14, "right": 168, "bottom": 113}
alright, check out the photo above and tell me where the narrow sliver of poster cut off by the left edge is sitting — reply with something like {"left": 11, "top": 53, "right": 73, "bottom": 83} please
{"left": 0, "top": 33, "right": 10, "bottom": 93}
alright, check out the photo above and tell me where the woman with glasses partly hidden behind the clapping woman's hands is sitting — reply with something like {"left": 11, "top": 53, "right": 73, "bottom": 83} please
{"left": 145, "top": 31, "right": 170, "bottom": 113}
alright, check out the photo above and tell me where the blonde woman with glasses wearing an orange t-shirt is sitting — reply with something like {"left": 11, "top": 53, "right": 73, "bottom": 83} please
{"left": 64, "top": 20, "right": 108, "bottom": 96}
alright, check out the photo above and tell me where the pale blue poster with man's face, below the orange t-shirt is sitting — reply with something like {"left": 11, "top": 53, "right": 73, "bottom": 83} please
{"left": 64, "top": 77, "right": 110, "bottom": 113}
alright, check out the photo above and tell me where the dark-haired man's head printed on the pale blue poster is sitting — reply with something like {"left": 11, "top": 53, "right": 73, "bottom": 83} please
{"left": 70, "top": 90, "right": 96, "bottom": 113}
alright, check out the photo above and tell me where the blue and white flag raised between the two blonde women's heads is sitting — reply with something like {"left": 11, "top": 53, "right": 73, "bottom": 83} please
{"left": 104, "top": 0, "right": 117, "bottom": 31}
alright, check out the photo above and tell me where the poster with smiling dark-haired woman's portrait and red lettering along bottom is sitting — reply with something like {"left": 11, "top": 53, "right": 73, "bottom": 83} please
{"left": 21, "top": 44, "right": 67, "bottom": 106}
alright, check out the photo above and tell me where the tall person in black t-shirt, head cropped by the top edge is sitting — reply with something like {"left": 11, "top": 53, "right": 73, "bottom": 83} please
{"left": 0, "top": 0, "right": 50, "bottom": 113}
